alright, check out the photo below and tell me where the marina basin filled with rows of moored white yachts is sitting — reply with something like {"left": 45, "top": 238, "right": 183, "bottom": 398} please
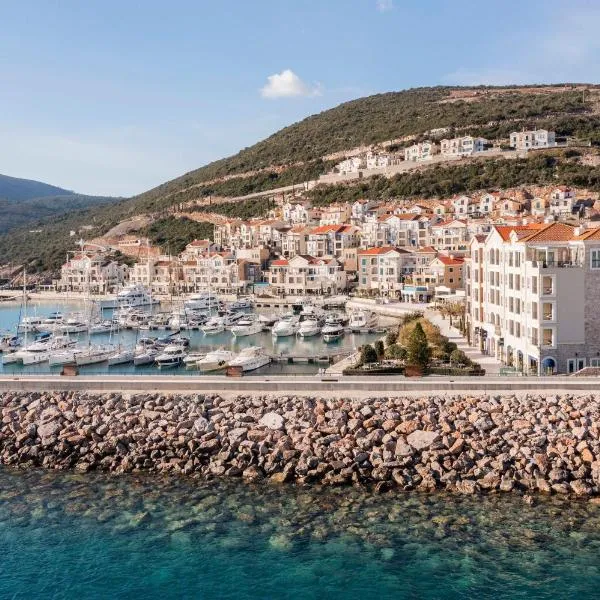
{"left": 0, "top": 290, "right": 386, "bottom": 376}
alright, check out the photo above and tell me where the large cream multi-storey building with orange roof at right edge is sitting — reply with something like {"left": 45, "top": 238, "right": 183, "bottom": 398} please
{"left": 465, "top": 223, "right": 600, "bottom": 374}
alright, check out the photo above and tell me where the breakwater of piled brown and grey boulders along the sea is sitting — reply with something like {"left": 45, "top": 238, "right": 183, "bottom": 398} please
{"left": 0, "top": 392, "right": 600, "bottom": 495}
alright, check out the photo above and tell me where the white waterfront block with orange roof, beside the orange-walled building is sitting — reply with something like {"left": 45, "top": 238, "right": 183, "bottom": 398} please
{"left": 358, "top": 246, "right": 415, "bottom": 296}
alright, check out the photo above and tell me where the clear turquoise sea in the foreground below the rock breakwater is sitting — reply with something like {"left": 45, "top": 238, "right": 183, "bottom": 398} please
{"left": 0, "top": 470, "right": 600, "bottom": 600}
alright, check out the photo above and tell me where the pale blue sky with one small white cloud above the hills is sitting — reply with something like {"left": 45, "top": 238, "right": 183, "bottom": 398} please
{"left": 0, "top": 0, "right": 600, "bottom": 196}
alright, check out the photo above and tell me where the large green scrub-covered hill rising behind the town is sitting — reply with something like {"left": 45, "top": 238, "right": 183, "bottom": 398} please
{"left": 0, "top": 84, "right": 600, "bottom": 270}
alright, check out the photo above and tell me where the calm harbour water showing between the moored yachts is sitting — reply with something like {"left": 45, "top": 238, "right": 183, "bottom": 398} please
{"left": 0, "top": 302, "right": 381, "bottom": 376}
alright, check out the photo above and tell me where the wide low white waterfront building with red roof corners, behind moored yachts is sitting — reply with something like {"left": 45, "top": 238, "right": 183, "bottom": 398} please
{"left": 267, "top": 255, "right": 348, "bottom": 296}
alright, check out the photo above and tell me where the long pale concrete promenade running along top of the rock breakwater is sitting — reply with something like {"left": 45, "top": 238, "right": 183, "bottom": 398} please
{"left": 0, "top": 375, "right": 600, "bottom": 398}
